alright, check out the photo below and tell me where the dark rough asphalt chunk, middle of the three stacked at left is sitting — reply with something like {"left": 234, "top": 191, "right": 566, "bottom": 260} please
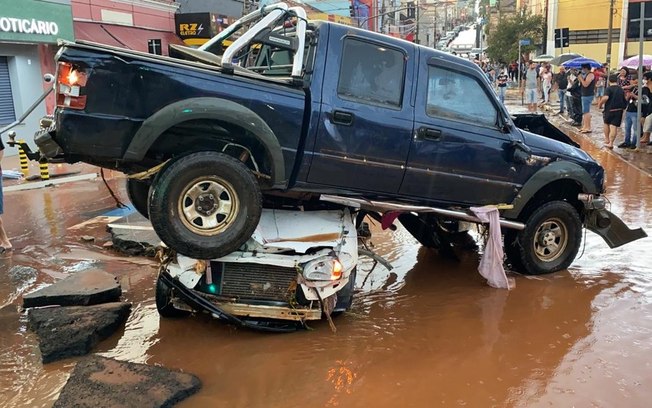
{"left": 28, "top": 303, "right": 131, "bottom": 364}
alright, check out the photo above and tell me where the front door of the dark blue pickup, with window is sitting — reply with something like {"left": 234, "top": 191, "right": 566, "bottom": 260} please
{"left": 400, "top": 56, "right": 518, "bottom": 205}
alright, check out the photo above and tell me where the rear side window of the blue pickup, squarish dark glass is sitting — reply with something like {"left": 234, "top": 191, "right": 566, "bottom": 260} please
{"left": 337, "top": 38, "right": 405, "bottom": 108}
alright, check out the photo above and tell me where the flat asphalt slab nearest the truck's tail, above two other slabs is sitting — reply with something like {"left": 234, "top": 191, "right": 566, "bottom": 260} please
{"left": 23, "top": 269, "right": 122, "bottom": 308}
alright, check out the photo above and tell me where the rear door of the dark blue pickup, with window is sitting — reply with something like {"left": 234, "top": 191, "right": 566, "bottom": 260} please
{"left": 308, "top": 31, "right": 415, "bottom": 194}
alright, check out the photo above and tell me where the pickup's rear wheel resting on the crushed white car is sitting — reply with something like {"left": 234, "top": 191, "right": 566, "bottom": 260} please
{"left": 149, "top": 152, "right": 262, "bottom": 259}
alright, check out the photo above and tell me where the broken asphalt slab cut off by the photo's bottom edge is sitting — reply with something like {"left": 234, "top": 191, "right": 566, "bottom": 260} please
{"left": 54, "top": 356, "right": 201, "bottom": 408}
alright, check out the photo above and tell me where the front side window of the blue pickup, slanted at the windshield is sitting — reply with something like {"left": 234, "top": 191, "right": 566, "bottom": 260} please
{"left": 426, "top": 66, "right": 498, "bottom": 126}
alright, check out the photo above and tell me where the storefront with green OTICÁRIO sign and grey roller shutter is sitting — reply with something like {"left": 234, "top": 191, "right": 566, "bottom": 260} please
{"left": 0, "top": 0, "right": 74, "bottom": 154}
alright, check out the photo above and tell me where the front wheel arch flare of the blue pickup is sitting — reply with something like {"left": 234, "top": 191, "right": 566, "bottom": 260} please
{"left": 502, "top": 161, "right": 600, "bottom": 220}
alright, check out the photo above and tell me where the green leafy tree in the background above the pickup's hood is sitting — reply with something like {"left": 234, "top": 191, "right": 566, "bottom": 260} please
{"left": 487, "top": 14, "right": 546, "bottom": 63}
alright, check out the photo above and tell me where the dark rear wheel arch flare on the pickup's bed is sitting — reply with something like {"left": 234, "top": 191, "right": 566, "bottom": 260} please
{"left": 124, "top": 97, "right": 286, "bottom": 185}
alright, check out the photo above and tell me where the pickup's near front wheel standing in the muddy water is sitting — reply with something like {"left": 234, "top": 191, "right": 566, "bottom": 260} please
{"left": 505, "top": 201, "right": 582, "bottom": 275}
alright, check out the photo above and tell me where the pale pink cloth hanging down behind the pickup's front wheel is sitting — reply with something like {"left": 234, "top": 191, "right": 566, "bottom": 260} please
{"left": 471, "top": 205, "right": 513, "bottom": 289}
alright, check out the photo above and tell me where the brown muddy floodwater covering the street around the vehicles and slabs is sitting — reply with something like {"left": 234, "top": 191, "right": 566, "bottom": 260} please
{"left": 0, "top": 139, "right": 652, "bottom": 407}
